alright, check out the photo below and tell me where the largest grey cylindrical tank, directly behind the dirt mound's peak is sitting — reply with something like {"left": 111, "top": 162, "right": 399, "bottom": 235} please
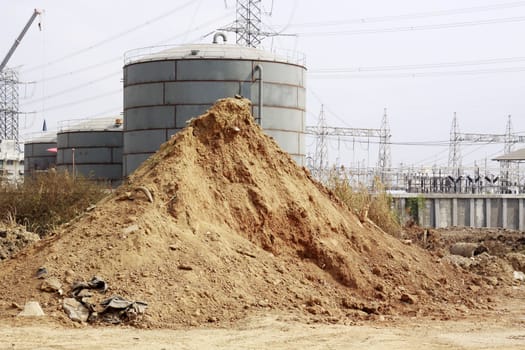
{"left": 123, "top": 44, "right": 306, "bottom": 176}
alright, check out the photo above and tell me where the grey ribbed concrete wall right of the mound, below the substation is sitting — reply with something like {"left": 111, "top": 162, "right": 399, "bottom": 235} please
{"left": 392, "top": 193, "right": 525, "bottom": 231}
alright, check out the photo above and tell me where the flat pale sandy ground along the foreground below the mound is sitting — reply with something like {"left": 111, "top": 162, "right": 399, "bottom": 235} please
{"left": 0, "top": 286, "right": 525, "bottom": 350}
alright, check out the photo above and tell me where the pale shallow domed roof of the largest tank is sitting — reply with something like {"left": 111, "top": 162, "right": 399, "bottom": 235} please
{"left": 124, "top": 44, "right": 305, "bottom": 66}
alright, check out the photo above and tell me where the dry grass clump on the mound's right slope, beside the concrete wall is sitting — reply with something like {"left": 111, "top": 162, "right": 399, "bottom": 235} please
{"left": 326, "top": 169, "right": 401, "bottom": 237}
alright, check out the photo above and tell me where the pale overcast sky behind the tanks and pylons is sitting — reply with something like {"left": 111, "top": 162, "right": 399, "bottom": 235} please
{"left": 0, "top": 0, "right": 525, "bottom": 172}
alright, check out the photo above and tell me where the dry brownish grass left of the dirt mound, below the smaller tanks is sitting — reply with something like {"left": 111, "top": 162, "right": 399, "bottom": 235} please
{"left": 0, "top": 172, "right": 107, "bottom": 236}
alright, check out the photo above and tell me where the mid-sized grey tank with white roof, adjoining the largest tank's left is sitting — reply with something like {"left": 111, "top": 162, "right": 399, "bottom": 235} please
{"left": 57, "top": 117, "right": 123, "bottom": 184}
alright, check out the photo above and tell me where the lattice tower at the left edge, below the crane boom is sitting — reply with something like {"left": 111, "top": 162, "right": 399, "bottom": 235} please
{"left": 0, "top": 68, "right": 19, "bottom": 145}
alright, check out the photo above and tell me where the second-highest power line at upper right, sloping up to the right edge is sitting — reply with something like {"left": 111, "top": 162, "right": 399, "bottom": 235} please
{"left": 295, "top": 16, "right": 525, "bottom": 37}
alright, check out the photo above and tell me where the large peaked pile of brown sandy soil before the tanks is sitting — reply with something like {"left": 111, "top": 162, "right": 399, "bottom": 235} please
{"left": 0, "top": 99, "right": 483, "bottom": 327}
